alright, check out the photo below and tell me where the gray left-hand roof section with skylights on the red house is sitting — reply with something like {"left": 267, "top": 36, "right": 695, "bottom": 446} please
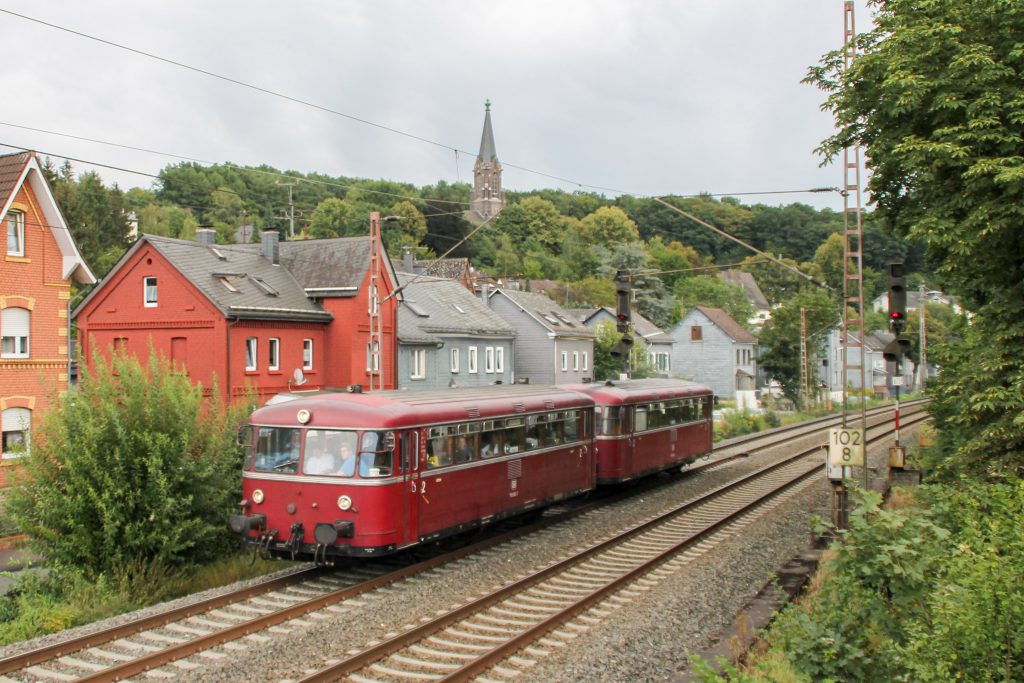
{"left": 74, "top": 234, "right": 334, "bottom": 323}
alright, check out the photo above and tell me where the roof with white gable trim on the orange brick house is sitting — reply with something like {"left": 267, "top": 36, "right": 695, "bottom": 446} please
{"left": 0, "top": 152, "right": 96, "bottom": 285}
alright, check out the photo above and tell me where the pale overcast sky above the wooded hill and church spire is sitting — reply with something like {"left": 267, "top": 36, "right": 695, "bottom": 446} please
{"left": 0, "top": 0, "right": 869, "bottom": 210}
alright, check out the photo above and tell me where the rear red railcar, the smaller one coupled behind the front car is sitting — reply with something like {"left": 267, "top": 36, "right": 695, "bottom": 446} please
{"left": 566, "top": 379, "right": 713, "bottom": 484}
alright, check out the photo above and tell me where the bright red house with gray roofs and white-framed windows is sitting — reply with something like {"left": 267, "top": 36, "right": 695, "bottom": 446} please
{"left": 75, "top": 230, "right": 398, "bottom": 403}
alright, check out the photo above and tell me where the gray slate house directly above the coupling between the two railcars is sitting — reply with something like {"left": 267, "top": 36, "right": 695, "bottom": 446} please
{"left": 488, "top": 289, "right": 596, "bottom": 384}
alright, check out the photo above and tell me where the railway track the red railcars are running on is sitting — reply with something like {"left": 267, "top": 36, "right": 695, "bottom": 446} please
{"left": 0, "top": 409, "right": 929, "bottom": 681}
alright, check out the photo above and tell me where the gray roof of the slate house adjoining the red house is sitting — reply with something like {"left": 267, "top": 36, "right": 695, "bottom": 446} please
{"left": 398, "top": 273, "right": 515, "bottom": 343}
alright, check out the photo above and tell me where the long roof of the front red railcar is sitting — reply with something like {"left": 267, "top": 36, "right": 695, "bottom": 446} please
{"left": 250, "top": 384, "right": 594, "bottom": 429}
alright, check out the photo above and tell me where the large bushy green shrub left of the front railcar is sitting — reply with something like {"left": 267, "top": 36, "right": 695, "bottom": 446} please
{"left": 5, "top": 353, "right": 244, "bottom": 577}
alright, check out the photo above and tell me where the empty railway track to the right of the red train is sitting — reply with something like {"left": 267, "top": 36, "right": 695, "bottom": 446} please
{"left": 299, "top": 411, "right": 924, "bottom": 683}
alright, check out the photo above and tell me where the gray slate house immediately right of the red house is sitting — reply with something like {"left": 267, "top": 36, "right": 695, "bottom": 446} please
{"left": 396, "top": 272, "right": 516, "bottom": 389}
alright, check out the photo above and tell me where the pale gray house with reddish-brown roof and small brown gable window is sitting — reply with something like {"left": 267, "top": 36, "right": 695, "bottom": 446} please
{"left": 669, "top": 306, "right": 758, "bottom": 408}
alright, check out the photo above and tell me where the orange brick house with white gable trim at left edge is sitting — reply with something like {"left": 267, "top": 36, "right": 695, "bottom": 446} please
{"left": 0, "top": 152, "right": 96, "bottom": 471}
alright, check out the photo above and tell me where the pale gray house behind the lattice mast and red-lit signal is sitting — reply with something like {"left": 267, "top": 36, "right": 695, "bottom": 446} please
{"left": 819, "top": 328, "right": 914, "bottom": 400}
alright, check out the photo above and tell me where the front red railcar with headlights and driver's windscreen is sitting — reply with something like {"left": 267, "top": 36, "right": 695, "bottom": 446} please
{"left": 230, "top": 385, "right": 596, "bottom": 561}
